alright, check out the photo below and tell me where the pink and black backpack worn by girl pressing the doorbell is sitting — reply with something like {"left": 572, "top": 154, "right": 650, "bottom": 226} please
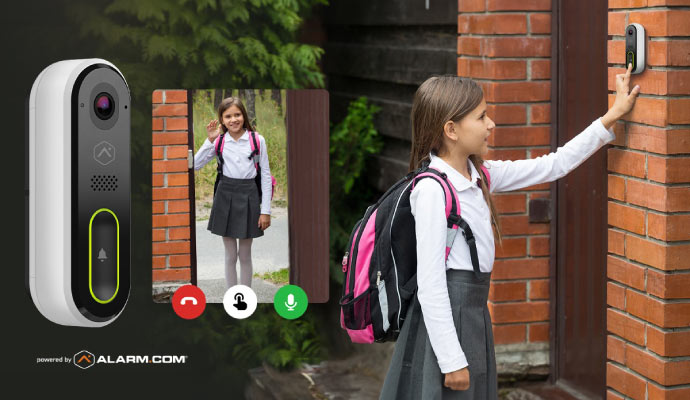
{"left": 340, "top": 165, "right": 491, "bottom": 343}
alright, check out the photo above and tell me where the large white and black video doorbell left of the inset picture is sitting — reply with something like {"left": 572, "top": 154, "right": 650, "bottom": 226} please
{"left": 25, "top": 58, "right": 131, "bottom": 327}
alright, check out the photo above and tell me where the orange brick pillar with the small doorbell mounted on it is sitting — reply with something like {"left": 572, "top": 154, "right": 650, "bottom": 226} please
{"left": 606, "top": 0, "right": 690, "bottom": 399}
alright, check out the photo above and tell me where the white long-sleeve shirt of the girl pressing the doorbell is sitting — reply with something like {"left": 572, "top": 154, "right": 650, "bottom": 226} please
{"left": 410, "top": 119, "right": 615, "bottom": 373}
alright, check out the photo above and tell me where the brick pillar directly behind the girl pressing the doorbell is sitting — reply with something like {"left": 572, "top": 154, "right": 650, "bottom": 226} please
{"left": 458, "top": 0, "right": 551, "bottom": 374}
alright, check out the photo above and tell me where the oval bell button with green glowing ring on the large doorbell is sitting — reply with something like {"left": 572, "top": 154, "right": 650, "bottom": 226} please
{"left": 89, "top": 208, "right": 120, "bottom": 304}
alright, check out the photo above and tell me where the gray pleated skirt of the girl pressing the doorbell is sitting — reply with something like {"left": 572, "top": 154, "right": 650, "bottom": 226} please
{"left": 379, "top": 269, "right": 498, "bottom": 400}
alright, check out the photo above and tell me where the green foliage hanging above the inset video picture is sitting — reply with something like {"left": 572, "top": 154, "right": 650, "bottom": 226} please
{"left": 71, "top": 0, "right": 327, "bottom": 99}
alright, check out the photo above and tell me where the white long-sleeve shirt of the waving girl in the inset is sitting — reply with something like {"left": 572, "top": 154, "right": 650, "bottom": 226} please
{"left": 194, "top": 129, "right": 272, "bottom": 214}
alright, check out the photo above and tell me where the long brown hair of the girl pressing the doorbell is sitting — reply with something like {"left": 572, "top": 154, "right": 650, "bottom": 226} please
{"left": 410, "top": 75, "right": 502, "bottom": 243}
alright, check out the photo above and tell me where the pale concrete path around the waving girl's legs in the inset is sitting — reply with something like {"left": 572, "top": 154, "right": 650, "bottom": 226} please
{"left": 196, "top": 208, "right": 290, "bottom": 303}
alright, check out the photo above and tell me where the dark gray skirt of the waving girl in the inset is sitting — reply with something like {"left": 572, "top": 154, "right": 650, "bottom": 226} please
{"left": 208, "top": 175, "right": 264, "bottom": 239}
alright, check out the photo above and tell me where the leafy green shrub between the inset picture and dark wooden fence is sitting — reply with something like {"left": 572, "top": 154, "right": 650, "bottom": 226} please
{"left": 330, "top": 97, "right": 383, "bottom": 283}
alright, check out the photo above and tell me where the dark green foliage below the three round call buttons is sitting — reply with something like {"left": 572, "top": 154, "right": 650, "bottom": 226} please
{"left": 152, "top": 304, "right": 325, "bottom": 388}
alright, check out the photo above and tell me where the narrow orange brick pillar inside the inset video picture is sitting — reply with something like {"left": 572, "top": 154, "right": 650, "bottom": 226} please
{"left": 152, "top": 90, "right": 191, "bottom": 294}
